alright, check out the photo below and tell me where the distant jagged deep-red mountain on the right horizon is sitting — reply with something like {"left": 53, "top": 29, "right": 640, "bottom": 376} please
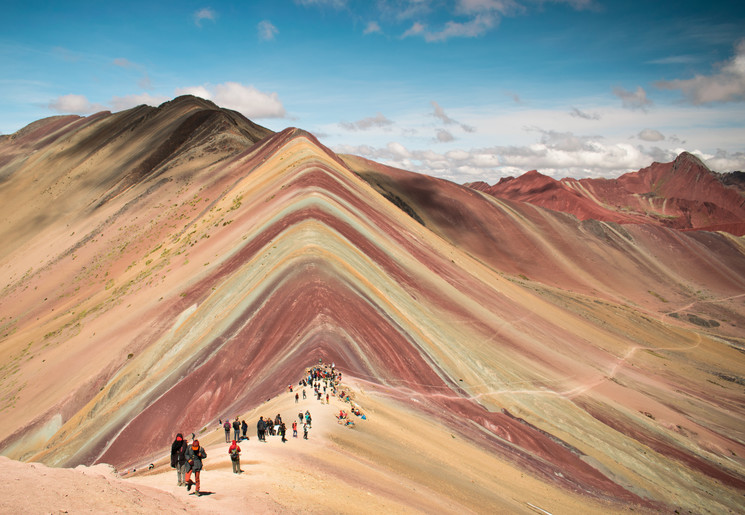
{"left": 467, "top": 152, "right": 745, "bottom": 236}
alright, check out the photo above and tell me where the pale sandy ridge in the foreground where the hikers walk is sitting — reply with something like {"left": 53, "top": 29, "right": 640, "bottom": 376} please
{"left": 0, "top": 378, "right": 644, "bottom": 514}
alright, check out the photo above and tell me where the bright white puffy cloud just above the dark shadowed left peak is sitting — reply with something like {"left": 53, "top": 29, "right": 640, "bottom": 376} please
{"left": 176, "top": 82, "right": 286, "bottom": 119}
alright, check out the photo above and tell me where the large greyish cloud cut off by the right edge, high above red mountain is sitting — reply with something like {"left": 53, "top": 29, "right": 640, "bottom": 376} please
{"left": 655, "top": 39, "right": 745, "bottom": 105}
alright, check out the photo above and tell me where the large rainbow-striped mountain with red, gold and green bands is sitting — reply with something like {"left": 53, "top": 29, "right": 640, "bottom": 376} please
{"left": 0, "top": 97, "right": 745, "bottom": 512}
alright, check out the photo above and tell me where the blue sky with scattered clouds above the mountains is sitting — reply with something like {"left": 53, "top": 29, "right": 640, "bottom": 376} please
{"left": 0, "top": 0, "right": 745, "bottom": 184}
